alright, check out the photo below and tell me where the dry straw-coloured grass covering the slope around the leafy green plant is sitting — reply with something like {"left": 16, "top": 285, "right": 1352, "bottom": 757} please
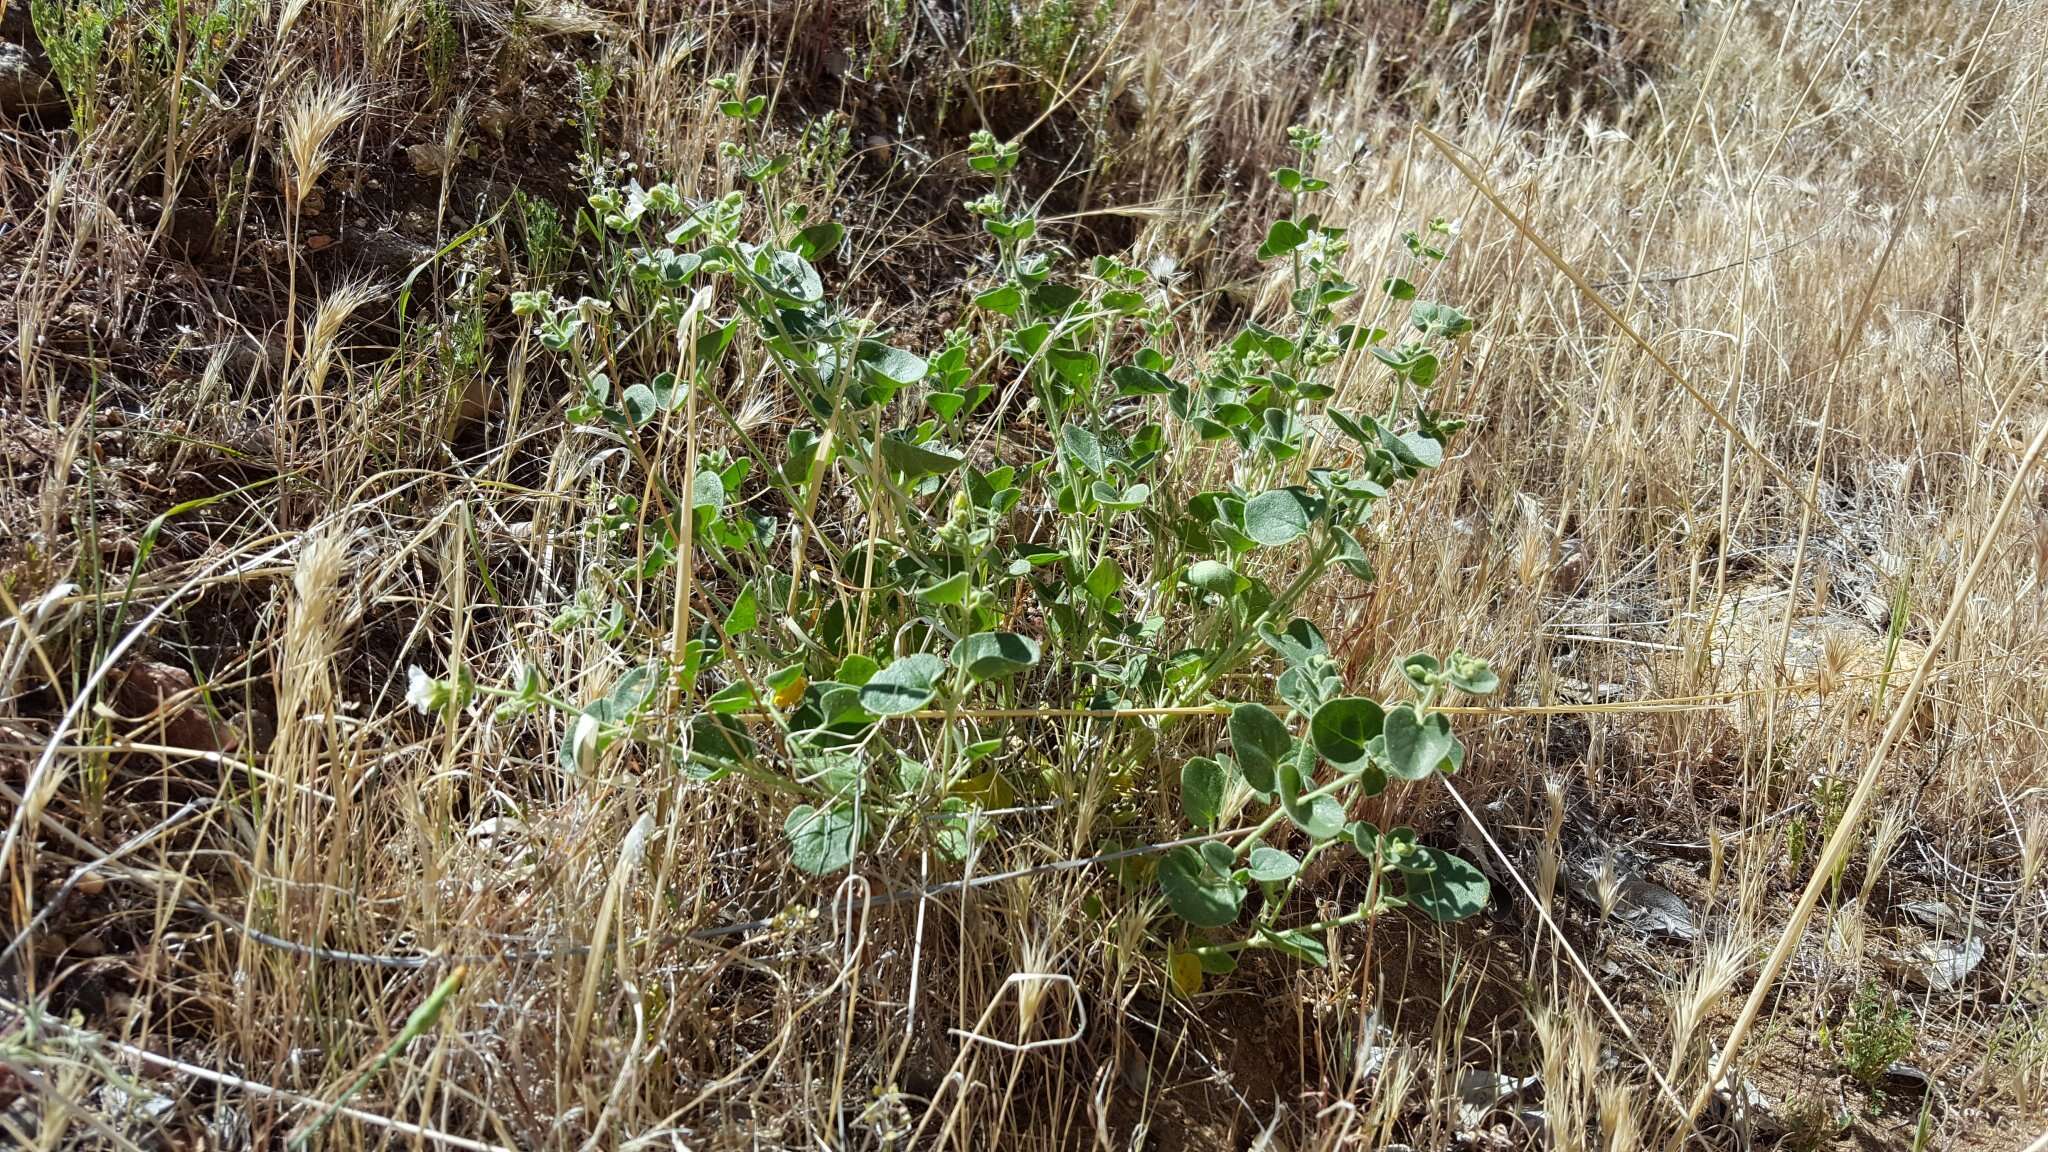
{"left": 0, "top": 0, "right": 2048, "bottom": 1152}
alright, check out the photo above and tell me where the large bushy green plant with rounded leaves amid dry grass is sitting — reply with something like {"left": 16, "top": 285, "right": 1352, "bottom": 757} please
{"left": 414, "top": 112, "right": 1499, "bottom": 984}
